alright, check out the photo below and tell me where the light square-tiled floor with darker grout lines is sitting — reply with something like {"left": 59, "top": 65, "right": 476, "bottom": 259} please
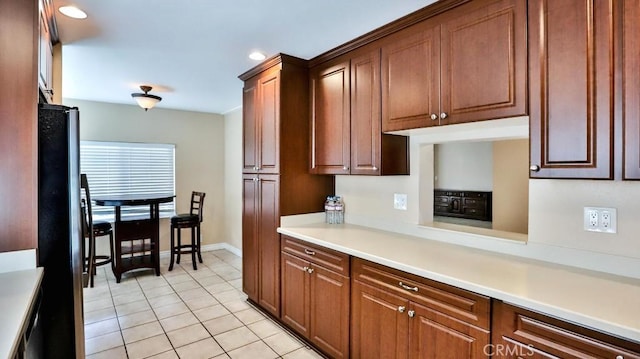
{"left": 84, "top": 250, "right": 322, "bottom": 359}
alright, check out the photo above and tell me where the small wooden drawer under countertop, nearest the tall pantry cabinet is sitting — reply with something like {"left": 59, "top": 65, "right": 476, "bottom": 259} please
{"left": 280, "top": 235, "right": 349, "bottom": 277}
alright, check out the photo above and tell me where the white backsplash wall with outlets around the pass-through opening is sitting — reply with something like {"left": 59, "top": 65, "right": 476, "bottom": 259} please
{"left": 336, "top": 119, "right": 640, "bottom": 278}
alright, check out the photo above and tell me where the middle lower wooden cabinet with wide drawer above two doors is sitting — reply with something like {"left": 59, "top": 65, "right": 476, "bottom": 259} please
{"left": 351, "top": 258, "right": 490, "bottom": 359}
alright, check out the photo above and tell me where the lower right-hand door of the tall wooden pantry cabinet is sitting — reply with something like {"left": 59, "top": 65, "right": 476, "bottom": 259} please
{"left": 257, "top": 175, "right": 280, "bottom": 317}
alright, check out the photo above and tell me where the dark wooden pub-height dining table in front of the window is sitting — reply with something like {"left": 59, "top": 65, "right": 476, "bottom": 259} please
{"left": 93, "top": 193, "right": 175, "bottom": 283}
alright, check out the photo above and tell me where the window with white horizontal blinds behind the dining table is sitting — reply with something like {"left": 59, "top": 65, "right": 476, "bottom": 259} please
{"left": 80, "top": 141, "right": 175, "bottom": 221}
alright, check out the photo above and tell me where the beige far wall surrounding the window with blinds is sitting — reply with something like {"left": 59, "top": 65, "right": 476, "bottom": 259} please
{"left": 63, "top": 99, "right": 225, "bottom": 251}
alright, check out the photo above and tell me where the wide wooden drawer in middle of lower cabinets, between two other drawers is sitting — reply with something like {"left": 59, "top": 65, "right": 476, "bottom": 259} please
{"left": 351, "top": 258, "right": 491, "bottom": 329}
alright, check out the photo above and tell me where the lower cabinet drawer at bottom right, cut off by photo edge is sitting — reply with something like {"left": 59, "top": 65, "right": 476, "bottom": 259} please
{"left": 492, "top": 300, "right": 640, "bottom": 359}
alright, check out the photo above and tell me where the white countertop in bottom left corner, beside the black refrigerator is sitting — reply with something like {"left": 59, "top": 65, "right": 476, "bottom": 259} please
{"left": 0, "top": 268, "right": 43, "bottom": 358}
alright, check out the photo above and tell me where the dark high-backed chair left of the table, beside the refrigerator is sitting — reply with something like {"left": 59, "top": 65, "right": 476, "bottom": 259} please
{"left": 80, "top": 173, "right": 114, "bottom": 288}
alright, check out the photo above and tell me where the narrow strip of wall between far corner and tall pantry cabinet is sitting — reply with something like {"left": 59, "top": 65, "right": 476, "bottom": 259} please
{"left": 224, "top": 108, "right": 243, "bottom": 255}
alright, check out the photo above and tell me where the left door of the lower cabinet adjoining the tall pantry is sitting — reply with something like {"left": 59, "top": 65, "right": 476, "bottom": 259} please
{"left": 281, "top": 252, "right": 310, "bottom": 338}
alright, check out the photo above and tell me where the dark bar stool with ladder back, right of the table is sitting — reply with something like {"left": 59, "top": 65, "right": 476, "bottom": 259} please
{"left": 169, "top": 191, "right": 205, "bottom": 271}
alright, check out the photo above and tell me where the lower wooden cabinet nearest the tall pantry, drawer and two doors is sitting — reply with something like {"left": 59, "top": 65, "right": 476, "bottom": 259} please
{"left": 280, "top": 236, "right": 351, "bottom": 358}
